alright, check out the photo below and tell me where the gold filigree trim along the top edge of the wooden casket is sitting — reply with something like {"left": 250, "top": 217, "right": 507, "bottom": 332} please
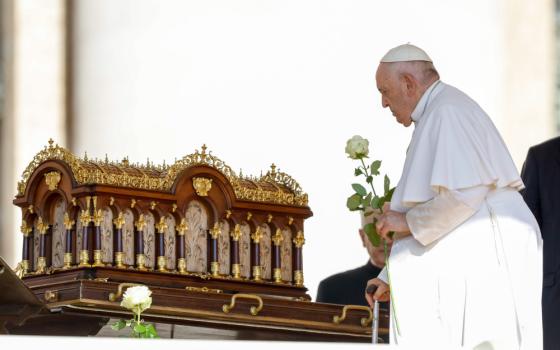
{"left": 18, "top": 139, "right": 308, "bottom": 206}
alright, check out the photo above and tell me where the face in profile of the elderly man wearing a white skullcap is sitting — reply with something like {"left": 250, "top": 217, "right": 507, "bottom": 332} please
{"left": 375, "top": 63, "right": 417, "bottom": 126}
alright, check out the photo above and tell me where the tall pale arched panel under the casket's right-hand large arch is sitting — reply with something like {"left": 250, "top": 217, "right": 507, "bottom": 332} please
{"left": 185, "top": 201, "right": 208, "bottom": 272}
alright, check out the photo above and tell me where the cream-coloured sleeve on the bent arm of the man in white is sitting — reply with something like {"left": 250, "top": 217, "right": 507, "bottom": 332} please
{"left": 406, "top": 185, "right": 490, "bottom": 246}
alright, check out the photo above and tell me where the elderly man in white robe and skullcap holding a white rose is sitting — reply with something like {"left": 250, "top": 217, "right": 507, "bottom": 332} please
{"left": 366, "top": 44, "right": 542, "bottom": 350}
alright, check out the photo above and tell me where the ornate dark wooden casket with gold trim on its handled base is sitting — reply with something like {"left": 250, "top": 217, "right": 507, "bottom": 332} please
{"left": 5, "top": 140, "right": 388, "bottom": 342}
